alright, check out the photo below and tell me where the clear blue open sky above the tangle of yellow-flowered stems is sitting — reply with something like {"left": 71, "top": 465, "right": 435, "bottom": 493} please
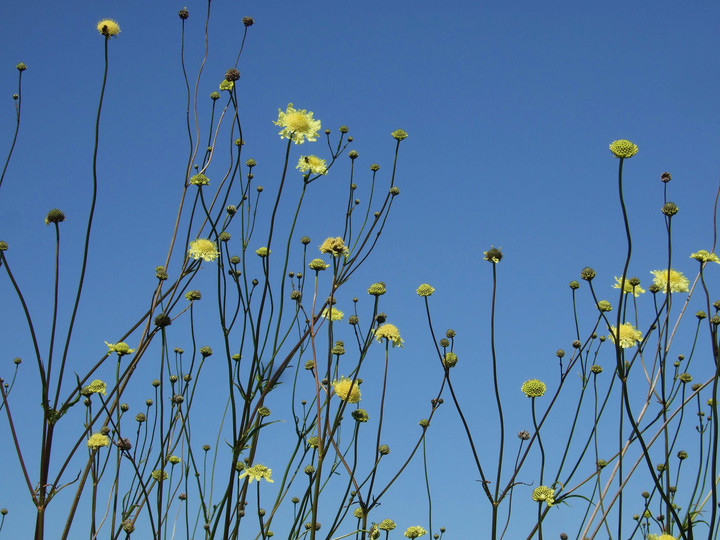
{"left": 0, "top": 0, "right": 720, "bottom": 538}
